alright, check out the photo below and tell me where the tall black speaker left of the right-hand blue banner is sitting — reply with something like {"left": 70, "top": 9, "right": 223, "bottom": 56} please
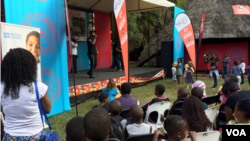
{"left": 161, "top": 41, "right": 173, "bottom": 78}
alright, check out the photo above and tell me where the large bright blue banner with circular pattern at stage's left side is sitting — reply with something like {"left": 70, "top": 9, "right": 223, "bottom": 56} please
{"left": 4, "top": 0, "right": 71, "bottom": 116}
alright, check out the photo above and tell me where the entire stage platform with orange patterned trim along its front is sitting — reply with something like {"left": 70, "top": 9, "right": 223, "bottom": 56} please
{"left": 69, "top": 67, "right": 166, "bottom": 106}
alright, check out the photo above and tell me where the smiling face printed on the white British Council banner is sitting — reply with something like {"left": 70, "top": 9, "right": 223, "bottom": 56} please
{"left": 26, "top": 31, "right": 41, "bottom": 64}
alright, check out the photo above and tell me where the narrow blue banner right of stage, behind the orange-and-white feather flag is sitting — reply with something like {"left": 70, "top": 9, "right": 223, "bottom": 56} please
{"left": 173, "top": 7, "right": 185, "bottom": 71}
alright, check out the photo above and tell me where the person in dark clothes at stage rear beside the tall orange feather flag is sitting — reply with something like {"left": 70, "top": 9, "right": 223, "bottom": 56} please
{"left": 110, "top": 42, "right": 122, "bottom": 71}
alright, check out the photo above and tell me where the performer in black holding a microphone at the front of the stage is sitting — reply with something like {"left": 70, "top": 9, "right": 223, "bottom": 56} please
{"left": 87, "top": 30, "right": 99, "bottom": 78}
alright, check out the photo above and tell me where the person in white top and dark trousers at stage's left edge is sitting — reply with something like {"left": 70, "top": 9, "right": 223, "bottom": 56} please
{"left": 71, "top": 38, "right": 78, "bottom": 73}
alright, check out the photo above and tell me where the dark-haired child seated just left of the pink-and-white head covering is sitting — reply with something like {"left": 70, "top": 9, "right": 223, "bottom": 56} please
{"left": 169, "top": 88, "right": 189, "bottom": 116}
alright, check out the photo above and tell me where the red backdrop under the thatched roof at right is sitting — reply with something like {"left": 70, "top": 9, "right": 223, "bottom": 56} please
{"left": 184, "top": 41, "right": 248, "bottom": 70}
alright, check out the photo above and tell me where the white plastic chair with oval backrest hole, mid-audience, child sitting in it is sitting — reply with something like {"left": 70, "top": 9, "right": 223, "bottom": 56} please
{"left": 144, "top": 101, "right": 171, "bottom": 133}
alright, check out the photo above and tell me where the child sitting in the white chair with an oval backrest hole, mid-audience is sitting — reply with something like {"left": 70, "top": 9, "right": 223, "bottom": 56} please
{"left": 148, "top": 84, "right": 170, "bottom": 124}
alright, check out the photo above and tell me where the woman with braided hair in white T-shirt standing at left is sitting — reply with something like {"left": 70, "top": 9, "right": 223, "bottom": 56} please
{"left": 0, "top": 48, "right": 51, "bottom": 141}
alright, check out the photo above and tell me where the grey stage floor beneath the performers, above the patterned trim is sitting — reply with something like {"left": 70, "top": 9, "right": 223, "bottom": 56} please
{"left": 69, "top": 67, "right": 163, "bottom": 87}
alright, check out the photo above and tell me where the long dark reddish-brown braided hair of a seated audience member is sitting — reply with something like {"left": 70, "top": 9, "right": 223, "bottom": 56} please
{"left": 182, "top": 96, "right": 213, "bottom": 132}
